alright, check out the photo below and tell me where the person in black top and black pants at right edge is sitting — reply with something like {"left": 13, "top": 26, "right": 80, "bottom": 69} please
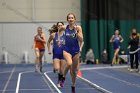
{"left": 128, "top": 28, "right": 139, "bottom": 72}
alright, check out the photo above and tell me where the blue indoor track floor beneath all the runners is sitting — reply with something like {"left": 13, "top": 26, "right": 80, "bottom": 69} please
{"left": 0, "top": 64, "right": 140, "bottom": 93}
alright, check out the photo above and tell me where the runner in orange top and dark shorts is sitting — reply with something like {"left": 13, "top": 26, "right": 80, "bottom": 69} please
{"left": 33, "top": 27, "right": 46, "bottom": 72}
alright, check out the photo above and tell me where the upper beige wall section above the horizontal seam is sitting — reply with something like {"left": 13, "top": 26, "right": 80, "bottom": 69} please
{"left": 0, "top": 0, "right": 80, "bottom": 22}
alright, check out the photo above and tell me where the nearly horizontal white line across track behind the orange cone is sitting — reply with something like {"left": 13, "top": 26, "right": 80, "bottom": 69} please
{"left": 80, "top": 65, "right": 128, "bottom": 70}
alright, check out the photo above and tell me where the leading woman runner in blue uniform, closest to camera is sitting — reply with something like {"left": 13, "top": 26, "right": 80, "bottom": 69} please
{"left": 61, "top": 13, "right": 83, "bottom": 93}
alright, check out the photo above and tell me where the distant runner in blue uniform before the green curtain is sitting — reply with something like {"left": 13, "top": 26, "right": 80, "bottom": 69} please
{"left": 110, "top": 30, "right": 123, "bottom": 66}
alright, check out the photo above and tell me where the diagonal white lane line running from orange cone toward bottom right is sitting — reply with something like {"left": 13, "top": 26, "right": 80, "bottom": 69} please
{"left": 78, "top": 76, "right": 112, "bottom": 93}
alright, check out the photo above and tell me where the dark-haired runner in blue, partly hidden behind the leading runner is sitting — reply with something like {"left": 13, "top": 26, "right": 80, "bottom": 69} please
{"left": 47, "top": 22, "right": 65, "bottom": 87}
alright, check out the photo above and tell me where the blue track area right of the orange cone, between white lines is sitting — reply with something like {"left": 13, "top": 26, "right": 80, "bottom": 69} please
{"left": 82, "top": 64, "right": 140, "bottom": 93}
